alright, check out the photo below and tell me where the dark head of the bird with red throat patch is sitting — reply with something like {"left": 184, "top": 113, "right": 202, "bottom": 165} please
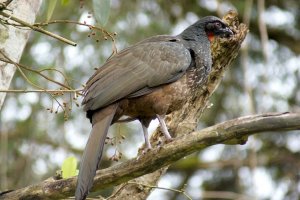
{"left": 200, "top": 16, "right": 233, "bottom": 42}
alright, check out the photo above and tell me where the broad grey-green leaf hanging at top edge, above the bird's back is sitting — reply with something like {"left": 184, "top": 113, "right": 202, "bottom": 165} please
{"left": 93, "top": 0, "right": 110, "bottom": 26}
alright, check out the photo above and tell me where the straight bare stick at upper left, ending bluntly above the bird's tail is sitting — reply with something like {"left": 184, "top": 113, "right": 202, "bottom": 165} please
{"left": 0, "top": 11, "right": 77, "bottom": 46}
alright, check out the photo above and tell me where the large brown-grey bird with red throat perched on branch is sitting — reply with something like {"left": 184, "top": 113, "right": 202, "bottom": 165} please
{"left": 75, "top": 16, "right": 234, "bottom": 200}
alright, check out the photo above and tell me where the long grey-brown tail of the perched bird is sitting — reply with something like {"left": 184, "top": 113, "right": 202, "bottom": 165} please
{"left": 75, "top": 104, "right": 117, "bottom": 200}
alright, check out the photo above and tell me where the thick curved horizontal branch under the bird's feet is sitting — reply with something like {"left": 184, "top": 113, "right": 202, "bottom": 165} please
{"left": 0, "top": 113, "right": 300, "bottom": 199}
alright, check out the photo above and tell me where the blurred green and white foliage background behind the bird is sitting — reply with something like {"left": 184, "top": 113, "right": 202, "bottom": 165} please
{"left": 0, "top": 0, "right": 300, "bottom": 200}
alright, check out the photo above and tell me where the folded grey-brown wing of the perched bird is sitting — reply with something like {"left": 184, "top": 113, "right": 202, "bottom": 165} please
{"left": 82, "top": 36, "right": 191, "bottom": 110}
